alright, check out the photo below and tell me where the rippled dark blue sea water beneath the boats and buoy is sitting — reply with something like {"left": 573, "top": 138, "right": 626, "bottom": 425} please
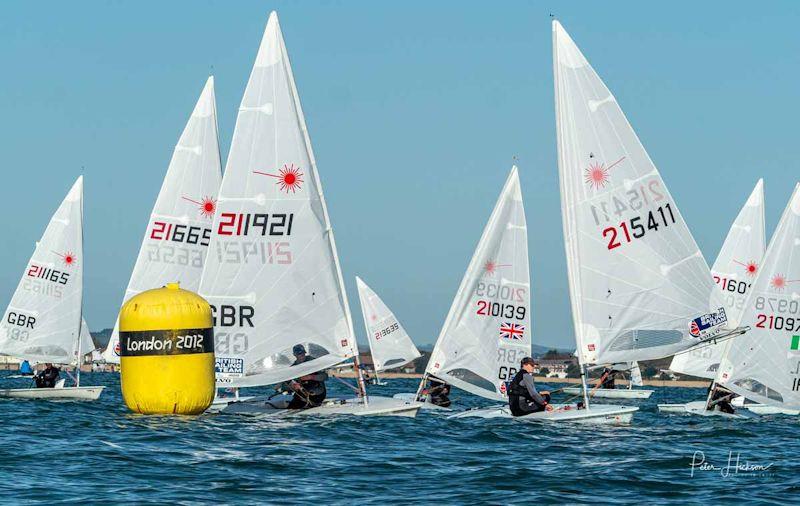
{"left": 0, "top": 373, "right": 800, "bottom": 504}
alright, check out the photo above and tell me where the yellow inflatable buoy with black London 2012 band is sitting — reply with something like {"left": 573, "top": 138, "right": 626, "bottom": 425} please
{"left": 119, "top": 283, "right": 215, "bottom": 415}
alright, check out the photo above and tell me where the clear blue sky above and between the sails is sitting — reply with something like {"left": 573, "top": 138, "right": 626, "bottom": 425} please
{"left": 0, "top": 0, "right": 800, "bottom": 347}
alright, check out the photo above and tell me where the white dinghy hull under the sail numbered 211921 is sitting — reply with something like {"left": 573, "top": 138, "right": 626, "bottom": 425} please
{"left": 216, "top": 395, "right": 422, "bottom": 418}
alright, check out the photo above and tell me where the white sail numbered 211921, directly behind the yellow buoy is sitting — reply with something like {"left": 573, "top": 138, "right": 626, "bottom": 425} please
{"left": 200, "top": 12, "right": 356, "bottom": 386}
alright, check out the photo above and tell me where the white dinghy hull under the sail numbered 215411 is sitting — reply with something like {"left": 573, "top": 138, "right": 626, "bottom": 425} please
{"left": 447, "top": 404, "right": 639, "bottom": 425}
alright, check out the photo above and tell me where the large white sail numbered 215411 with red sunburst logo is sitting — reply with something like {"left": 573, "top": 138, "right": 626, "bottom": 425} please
{"left": 553, "top": 21, "right": 727, "bottom": 364}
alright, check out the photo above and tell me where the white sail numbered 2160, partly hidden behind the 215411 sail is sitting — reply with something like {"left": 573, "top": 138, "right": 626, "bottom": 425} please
{"left": 669, "top": 179, "right": 766, "bottom": 379}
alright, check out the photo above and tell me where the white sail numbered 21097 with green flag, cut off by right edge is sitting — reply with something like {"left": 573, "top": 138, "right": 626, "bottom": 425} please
{"left": 716, "top": 185, "right": 800, "bottom": 409}
